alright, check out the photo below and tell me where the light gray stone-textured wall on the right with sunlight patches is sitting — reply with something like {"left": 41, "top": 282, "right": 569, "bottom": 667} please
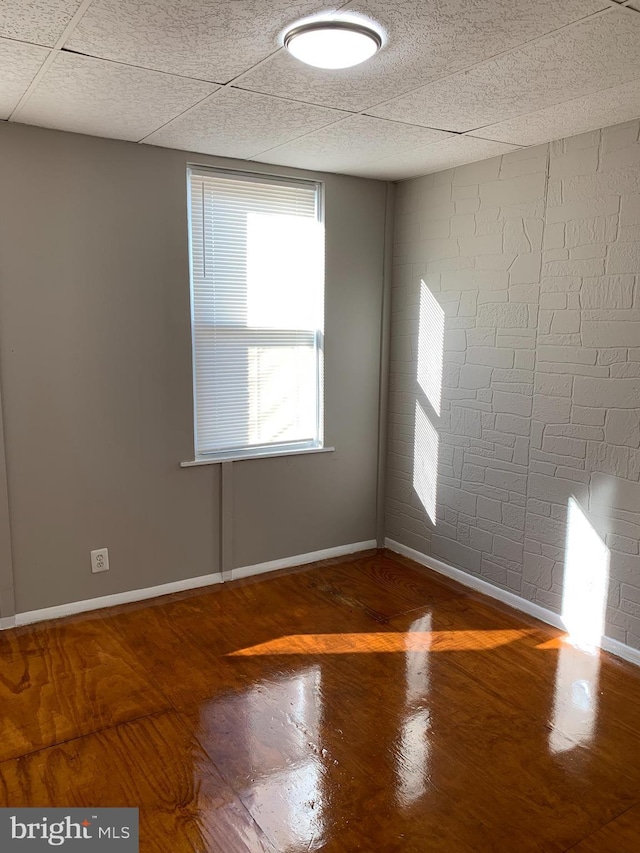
{"left": 387, "top": 121, "right": 640, "bottom": 648}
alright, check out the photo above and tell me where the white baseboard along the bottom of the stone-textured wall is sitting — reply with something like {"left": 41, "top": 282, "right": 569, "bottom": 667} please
{"left": 385, "top": 539, "right": 640, "bottom": 666}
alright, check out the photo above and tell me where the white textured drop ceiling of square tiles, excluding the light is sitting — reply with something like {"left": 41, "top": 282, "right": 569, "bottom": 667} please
{"left": 0, "top": 0, "right": 640, "bottom": 180}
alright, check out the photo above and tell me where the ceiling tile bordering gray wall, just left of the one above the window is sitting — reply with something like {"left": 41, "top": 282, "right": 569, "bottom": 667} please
{"left": 16, "top": 53, "right": 216, "bottom": 140}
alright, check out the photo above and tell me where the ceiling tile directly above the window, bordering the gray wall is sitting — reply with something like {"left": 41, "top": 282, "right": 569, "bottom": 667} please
{"left": 145, "top": 89, "right": 344, "bottom": 158}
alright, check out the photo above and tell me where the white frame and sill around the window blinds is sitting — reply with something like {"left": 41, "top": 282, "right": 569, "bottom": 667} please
{"left": 180, "top": 162, "right": 328, "bottom": 467}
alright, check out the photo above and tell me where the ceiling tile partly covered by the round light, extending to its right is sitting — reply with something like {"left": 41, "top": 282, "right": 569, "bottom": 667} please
{"left": 236, "top": 0, "right": 608, "bottom": 113}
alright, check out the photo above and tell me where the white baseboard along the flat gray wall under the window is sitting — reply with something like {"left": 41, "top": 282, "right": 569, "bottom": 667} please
{"left": 0, "top": 539, "right": 376, "bottom": 631}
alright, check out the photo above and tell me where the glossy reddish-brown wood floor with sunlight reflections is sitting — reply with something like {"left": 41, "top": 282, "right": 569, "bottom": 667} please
{"left": 0, "top": 552, "right": 640, "bottom": 853}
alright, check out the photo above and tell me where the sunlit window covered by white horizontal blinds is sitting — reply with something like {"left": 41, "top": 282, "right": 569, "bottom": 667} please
{"left": 188, "top": 167, "right": 324, "bottom": 459}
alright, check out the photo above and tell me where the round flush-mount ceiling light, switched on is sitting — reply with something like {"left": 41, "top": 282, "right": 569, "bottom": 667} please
{"left": 284, "top": 21, "right": 382, "bottom": 68}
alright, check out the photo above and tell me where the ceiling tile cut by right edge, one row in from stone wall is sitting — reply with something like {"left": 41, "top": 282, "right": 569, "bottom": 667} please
{"left": 370, "top": 10, "right": 640, "bottom": 132}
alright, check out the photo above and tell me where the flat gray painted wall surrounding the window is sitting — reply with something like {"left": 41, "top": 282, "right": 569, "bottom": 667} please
{"left": 0, "top": 123, "right": 385, "bottom": 612}
